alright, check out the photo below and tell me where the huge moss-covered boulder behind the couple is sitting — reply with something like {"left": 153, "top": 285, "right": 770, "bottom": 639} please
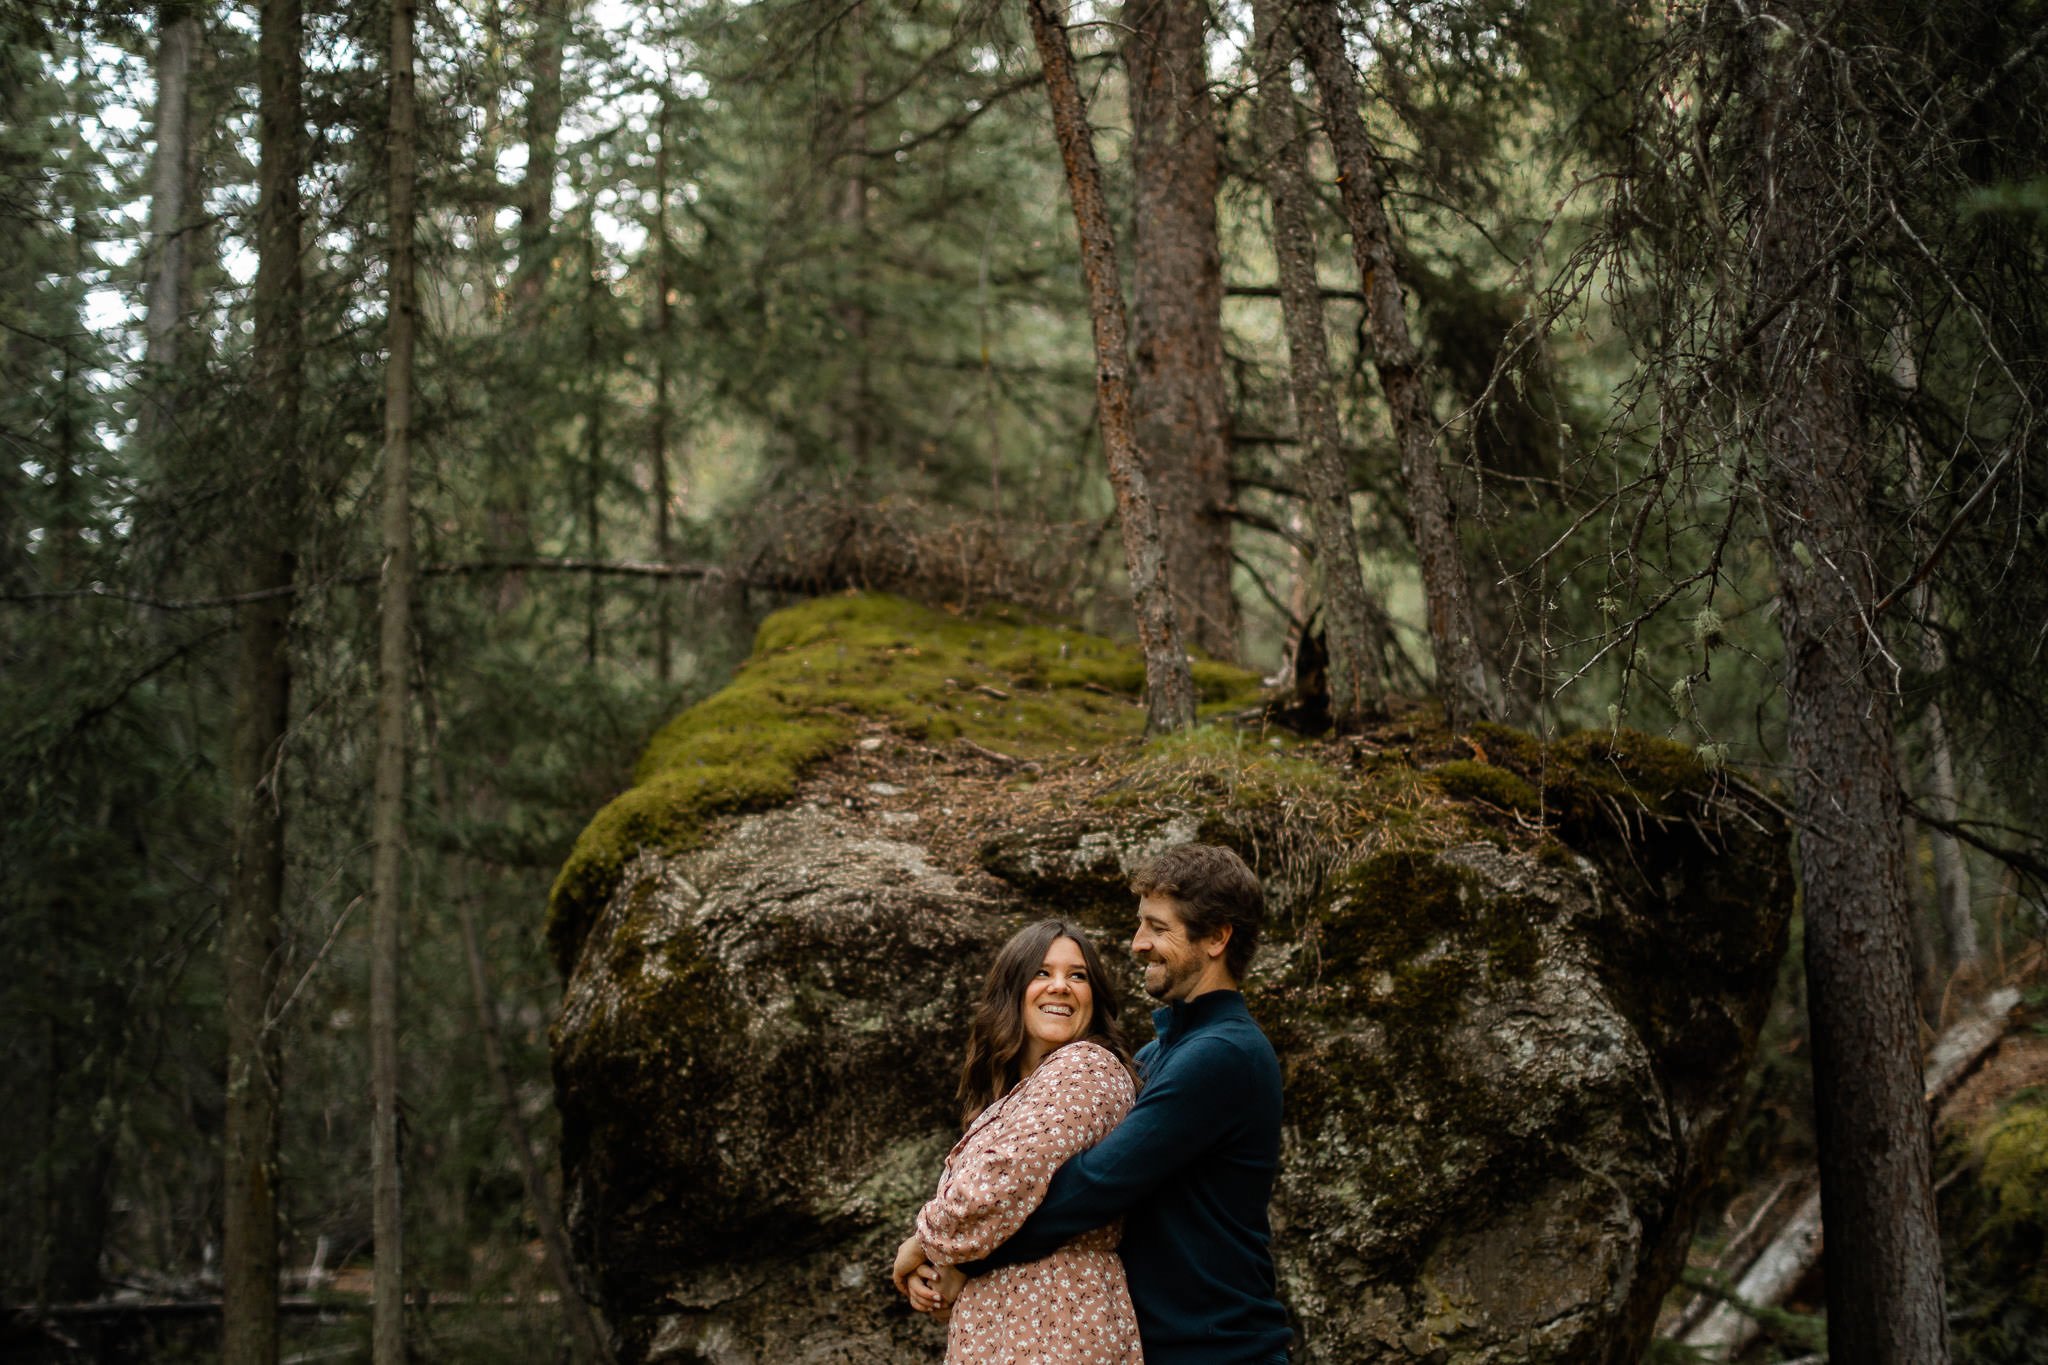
{"left": 551, "top": 598, "right": 1790, "bottom": 1365}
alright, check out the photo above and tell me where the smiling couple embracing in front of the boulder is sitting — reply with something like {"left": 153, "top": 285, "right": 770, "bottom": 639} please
{"left": 893, "top": 843, "right": 1290, "bottom": 1365}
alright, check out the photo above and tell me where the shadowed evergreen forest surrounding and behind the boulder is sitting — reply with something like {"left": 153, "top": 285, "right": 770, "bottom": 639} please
{"left": 0, "top": 0, "right": 2048, "bottom": 1363}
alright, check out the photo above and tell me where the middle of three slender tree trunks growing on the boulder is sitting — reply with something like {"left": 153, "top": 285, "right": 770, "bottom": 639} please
{"left": 1251, "top": 0, "right": 1386, "bottom": 731}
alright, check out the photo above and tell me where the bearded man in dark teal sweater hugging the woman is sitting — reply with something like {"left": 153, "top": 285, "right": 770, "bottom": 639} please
{"left": 897, "top": 843, "right": 1292, "bottom": 1365}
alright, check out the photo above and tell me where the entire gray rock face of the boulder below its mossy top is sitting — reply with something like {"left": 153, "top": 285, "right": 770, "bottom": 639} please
{"left": 555, "top": 749, "right": 1790, "bottom": 1365}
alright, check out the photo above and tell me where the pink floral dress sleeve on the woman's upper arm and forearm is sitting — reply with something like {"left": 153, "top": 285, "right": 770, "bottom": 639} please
{"left": 918, "top": 1044, "right": 1133, "bottom": 1265}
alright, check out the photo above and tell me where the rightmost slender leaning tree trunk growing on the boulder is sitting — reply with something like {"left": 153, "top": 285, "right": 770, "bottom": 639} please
{"left": 1296, "top": 0, "right": 1501, "bottom": 729}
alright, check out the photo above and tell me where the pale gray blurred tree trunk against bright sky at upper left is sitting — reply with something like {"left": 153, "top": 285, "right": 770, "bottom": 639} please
{"left": 137, "top": 0, "right": 199, "bottom": 444}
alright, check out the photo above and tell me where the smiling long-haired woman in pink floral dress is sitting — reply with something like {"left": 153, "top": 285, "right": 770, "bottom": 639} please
{"left": 895, "top": 919, "right": 1143, "bottom": 1365}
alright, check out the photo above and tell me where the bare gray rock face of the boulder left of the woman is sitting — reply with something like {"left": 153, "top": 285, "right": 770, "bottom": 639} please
{"left": 555, "top": 806, "right": 1008, "bottom": 1365}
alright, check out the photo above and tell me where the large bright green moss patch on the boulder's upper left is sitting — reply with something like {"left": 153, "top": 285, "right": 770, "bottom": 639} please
{"left": 549, "top": 593, "right": 1260, "bottom": 972}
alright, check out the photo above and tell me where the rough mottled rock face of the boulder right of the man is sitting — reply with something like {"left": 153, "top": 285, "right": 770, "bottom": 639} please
{"left": 1276, "top": 845, "right": 1690, "bottom": 1363}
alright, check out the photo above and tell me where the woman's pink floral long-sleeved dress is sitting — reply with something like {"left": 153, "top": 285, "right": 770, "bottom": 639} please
{"left": 918, "top": 1042, "right": 1145, "bottom": 1365}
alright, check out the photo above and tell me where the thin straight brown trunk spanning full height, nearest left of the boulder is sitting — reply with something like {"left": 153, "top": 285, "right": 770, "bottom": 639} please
{"left": 371, "top": 0, "right": 418, "bottom": 1365}
